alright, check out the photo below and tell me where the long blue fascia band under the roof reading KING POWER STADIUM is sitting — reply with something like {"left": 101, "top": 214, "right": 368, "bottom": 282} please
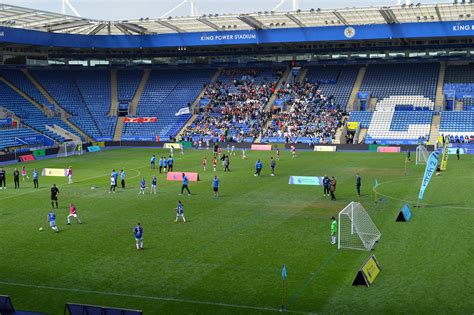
{"left": 0, "top": 21, "right": 474, "bottom": 49}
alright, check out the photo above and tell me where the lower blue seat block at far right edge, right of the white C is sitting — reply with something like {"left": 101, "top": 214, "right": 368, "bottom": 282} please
{"left": 439, "top": 111, "right": 474, "bottom": 142}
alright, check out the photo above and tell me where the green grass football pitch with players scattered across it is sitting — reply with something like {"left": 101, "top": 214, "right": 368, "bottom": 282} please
{"left": 0, "top": 148, "right": 474, "bottom": 314}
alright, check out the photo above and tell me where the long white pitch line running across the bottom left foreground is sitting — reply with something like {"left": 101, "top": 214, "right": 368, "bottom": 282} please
{"left": 0, "top": 281, "right": 310, "bottom": 314}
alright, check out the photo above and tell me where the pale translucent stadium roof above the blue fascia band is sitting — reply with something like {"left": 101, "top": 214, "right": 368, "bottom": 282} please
{"left": 0, "top": 3, "right": 474, "bottom": 35}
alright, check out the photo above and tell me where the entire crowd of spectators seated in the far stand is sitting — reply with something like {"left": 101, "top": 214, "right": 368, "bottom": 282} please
{"left": 184, "top": 69, "right": 342, "bottom": 143}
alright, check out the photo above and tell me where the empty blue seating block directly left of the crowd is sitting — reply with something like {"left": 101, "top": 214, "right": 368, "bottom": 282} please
{"left": 122, "top": 69, "right": 215, "bottom": 140}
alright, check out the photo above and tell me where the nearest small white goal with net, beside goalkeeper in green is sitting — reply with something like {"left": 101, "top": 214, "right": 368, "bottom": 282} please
{"left": 337, "top": 201, "right": 382, "bottom": 250}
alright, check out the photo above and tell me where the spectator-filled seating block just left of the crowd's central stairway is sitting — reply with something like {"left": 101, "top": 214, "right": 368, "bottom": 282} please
{"left": 184, "top": 68, "right": 281, "bottom": 142}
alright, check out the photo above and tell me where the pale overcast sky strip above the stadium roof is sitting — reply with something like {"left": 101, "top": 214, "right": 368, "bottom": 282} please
{"left": 0, "top": 0, "right": 453, "bottom": 20}
